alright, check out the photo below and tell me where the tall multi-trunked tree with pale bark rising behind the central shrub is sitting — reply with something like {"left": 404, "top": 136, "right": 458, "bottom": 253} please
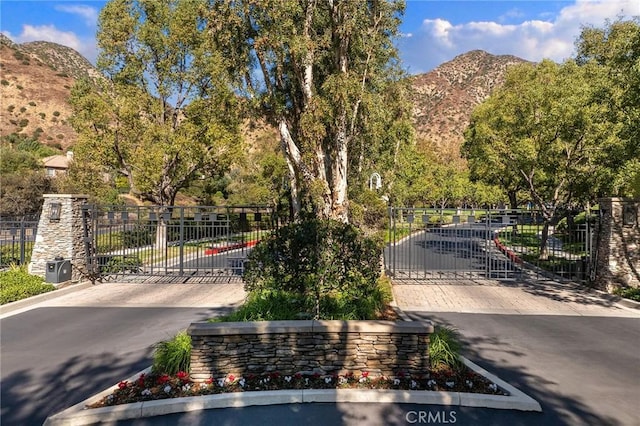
{"left": 207, "top": 0, "right": 404, "bottom": 222}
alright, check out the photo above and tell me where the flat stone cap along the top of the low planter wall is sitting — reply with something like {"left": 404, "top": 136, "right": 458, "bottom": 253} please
{"left": 187, "top": 320, "right": 433, "bottom": 336}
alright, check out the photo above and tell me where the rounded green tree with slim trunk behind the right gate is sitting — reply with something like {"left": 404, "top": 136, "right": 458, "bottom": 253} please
{"left": 463, "top": 60, "right": 611, "bottom": 257}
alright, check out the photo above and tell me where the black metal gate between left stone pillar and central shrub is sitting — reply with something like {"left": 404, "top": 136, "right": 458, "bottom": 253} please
{"left": 83, "top": 205, "right": 276, "bottom": 279}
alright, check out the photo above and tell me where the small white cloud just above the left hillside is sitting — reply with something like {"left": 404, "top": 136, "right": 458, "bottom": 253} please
{"left": 4, "top": 24, "right": 97, "bottom": 64}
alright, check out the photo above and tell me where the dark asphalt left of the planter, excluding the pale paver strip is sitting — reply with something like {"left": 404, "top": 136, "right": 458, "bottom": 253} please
{"left": 0, "top": 306, "right": 238, "bottom": 426}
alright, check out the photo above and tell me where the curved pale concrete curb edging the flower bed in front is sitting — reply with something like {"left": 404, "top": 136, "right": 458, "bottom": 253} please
{"left": 44, "top": 357, "right": 542, "bottom": 426}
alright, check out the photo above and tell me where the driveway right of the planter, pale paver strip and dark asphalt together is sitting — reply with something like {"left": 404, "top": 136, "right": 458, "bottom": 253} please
{"left": 394, "top": 281, "right": 640, "bottom": 426}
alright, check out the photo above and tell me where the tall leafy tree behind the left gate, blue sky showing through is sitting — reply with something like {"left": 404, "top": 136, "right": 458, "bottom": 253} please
{"left": 71, "top": 0, "right": 241, "bottom": 206}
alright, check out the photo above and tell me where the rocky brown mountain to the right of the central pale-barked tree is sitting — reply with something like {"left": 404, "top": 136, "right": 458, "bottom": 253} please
{"left": 411, "top": 50, "right": 526, "bottom": 161}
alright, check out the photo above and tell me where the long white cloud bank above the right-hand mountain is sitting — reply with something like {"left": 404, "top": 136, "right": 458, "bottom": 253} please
{"left": 399, "top": 0, "right": 640, "bottom": 74}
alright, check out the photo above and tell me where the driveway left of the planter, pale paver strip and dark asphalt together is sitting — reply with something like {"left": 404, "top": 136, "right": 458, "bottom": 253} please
{"left": 0, "top": 283, "right": 244, "bottom": 425}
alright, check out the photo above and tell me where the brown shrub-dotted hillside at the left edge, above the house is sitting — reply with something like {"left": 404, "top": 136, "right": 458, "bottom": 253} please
{"left": 0, "top": 34, "right": 100, "bottom": 149}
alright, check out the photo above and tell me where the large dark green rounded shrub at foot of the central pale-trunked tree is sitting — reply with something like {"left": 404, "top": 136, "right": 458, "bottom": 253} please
{"left": 244, "top": 219, "right": 382, "bottom": 318}
